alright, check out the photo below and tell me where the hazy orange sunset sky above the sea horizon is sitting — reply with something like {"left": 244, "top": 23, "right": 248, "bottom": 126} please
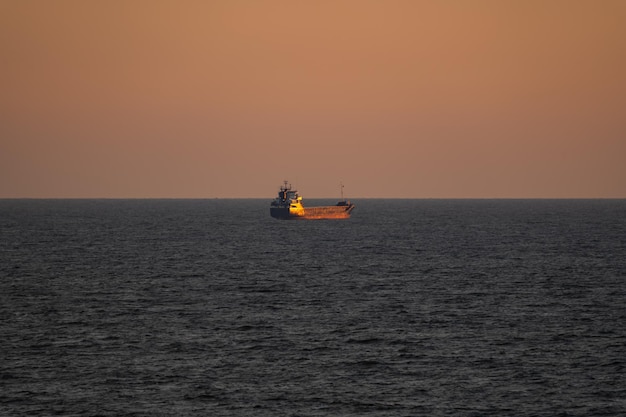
{"left": 0, "top": 0, "right": 626, "bottom": 199}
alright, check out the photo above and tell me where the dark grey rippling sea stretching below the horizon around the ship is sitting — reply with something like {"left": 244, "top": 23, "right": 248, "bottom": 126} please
{"left": 0, "top": 199, "right": 626, "bottom": 417}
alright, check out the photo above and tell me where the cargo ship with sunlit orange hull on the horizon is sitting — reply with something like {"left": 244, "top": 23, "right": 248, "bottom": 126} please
{"left": 270, "top": 181, "right": 354, "bottom": 220}
